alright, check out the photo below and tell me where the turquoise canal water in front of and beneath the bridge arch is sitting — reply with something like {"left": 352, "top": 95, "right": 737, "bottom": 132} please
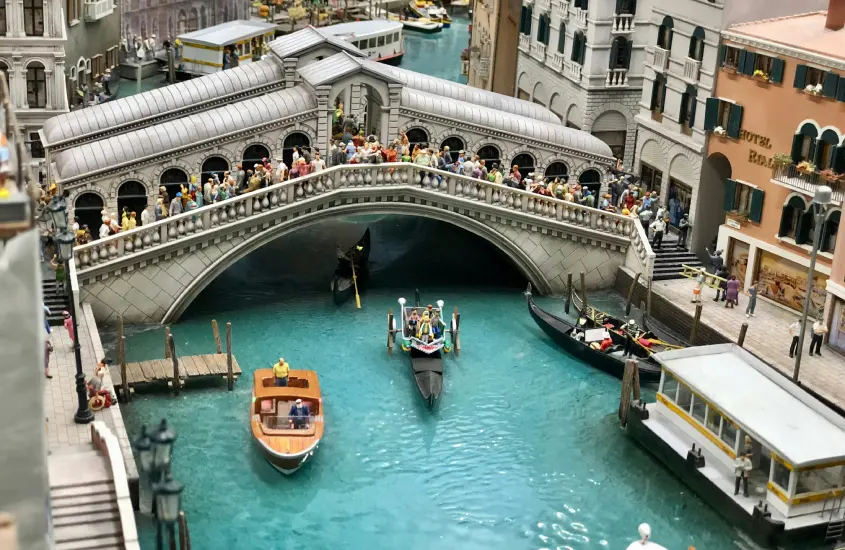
{"left": 115, "top": 217, "right": 750, "bottom": 550}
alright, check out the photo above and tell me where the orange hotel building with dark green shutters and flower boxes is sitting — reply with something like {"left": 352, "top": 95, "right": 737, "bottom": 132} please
{"left": 698, "top": 7, "right": 845, "bottom": 348}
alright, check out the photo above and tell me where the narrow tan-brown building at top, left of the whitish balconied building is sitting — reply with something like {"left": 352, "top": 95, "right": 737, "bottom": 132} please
{"left": 467, "top": 0, "right": 522, "bottom": 95}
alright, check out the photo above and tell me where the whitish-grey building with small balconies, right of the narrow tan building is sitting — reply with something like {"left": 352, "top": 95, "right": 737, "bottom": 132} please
{"left": 516, "top": 0, "right": 651, "bottom": 170}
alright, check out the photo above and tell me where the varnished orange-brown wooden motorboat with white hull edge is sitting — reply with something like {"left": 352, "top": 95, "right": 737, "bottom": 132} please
{"left": 249, "top": 369, "right": 323, "bottom": 474}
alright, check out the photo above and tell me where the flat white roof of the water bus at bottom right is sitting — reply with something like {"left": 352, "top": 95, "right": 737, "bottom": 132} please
{"left": 654, "top": 344, "right": 845, "bottom": 469}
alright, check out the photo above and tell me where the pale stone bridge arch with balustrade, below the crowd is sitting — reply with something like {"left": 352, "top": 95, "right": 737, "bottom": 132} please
{"left": 75, "top": 163, "right": 654, "bottom": 324}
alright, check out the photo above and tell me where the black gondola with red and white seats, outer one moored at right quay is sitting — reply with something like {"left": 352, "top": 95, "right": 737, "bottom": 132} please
{"left": 525, "top": 284, "right": 660, "bottom": 382}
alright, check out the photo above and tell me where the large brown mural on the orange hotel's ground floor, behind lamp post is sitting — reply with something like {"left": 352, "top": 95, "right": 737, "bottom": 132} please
{"left": 756, "top": 250, "right": 827, "bottom": 315}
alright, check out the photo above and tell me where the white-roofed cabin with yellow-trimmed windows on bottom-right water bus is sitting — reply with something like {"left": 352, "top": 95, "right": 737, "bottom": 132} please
{"left": 644, "top": 350, "right": 845, "bottom": 532}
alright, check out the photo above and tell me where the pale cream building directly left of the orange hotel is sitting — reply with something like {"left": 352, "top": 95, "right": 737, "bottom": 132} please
{"left": 630, "top": 0, "right": 827, "bottom": 252}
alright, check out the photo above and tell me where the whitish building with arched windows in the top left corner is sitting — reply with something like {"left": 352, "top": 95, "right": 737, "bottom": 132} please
{"left": 0, "top": 0, "right": 68, "bottom": 174}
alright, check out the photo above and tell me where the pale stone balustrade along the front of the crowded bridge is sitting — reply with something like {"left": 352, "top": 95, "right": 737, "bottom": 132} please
{"left": 76, "top": 163, "right": 651, "bottom": 274}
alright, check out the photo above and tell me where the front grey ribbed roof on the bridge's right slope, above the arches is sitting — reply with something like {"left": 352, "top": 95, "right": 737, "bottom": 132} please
{"left": 402, "top": 88, "right": 613, "bottom": 159}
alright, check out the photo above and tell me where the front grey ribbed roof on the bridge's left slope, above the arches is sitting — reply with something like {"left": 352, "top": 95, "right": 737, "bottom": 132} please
{"left": 53, "top": 86, "right": 317, "bottom": 181}
